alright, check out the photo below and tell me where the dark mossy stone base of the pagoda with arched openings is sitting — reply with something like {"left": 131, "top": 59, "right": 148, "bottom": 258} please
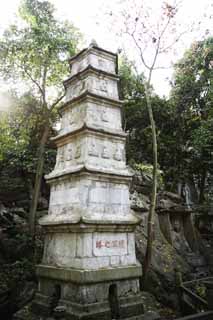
{"left": 32, "top": 266, "right": 143, "bottom": 320}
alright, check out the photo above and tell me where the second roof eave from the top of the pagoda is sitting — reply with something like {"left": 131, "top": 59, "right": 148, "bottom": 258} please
{"left": 63, "top": 65, "right": 120, "bottom": 89}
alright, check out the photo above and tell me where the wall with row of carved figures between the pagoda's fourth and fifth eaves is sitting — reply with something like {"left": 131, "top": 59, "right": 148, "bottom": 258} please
{"left": 54, "top": 134, "right": 126, "bottom": 173}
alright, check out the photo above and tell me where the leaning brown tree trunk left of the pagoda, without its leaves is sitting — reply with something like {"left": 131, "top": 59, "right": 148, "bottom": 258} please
{"left": 29, "top": 124, "right": 50, "bottom": 238}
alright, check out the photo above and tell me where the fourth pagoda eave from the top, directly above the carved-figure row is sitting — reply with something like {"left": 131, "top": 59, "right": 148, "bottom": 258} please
{"left": 51, "top": 123, "right": 127, "bottom": 146}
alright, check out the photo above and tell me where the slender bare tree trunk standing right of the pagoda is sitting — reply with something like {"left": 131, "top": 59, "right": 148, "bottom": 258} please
{"left": 143, "top": 83, "right": 157, "bottom": 287}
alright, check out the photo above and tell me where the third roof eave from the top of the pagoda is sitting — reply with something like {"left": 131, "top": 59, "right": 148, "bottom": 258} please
{"left": 58, "top": 90, "right": 124, "bottom": 111}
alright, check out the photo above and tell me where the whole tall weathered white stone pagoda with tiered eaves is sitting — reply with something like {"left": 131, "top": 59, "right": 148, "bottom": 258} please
{"left": 33, "top": 44, "right": 142, "bottom": 320}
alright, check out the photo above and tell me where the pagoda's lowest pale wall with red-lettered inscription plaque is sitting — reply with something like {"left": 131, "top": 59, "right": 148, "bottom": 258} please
{"left": 43, "top": 232, "right": 137, "bottom": 270}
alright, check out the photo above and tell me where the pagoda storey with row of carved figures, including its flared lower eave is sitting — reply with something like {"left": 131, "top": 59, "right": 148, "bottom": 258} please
{"left": 46, "top": 128, "right": 131, "bottom": 179}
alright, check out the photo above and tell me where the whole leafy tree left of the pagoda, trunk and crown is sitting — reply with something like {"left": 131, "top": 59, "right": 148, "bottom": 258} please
{"left": 0, "top": 0, "right": 80, "bottom": 235}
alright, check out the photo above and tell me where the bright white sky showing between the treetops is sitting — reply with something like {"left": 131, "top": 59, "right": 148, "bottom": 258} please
{"left": 0, "top": 0, "right": 213, "bottom": 95}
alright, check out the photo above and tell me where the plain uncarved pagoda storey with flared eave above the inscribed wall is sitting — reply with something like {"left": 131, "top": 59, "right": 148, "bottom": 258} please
{"left": 40, "top": 172, "right": 138, "bottom": 225}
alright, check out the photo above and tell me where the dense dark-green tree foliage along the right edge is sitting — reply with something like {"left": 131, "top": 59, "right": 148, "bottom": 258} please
{"left": 170, "top": 37, "right": 213, "bottom": 201}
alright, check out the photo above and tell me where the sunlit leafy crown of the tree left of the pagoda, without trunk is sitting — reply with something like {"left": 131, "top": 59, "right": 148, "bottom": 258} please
{"left": 0, "top": 0, "right": 80, "bottom": 95}
